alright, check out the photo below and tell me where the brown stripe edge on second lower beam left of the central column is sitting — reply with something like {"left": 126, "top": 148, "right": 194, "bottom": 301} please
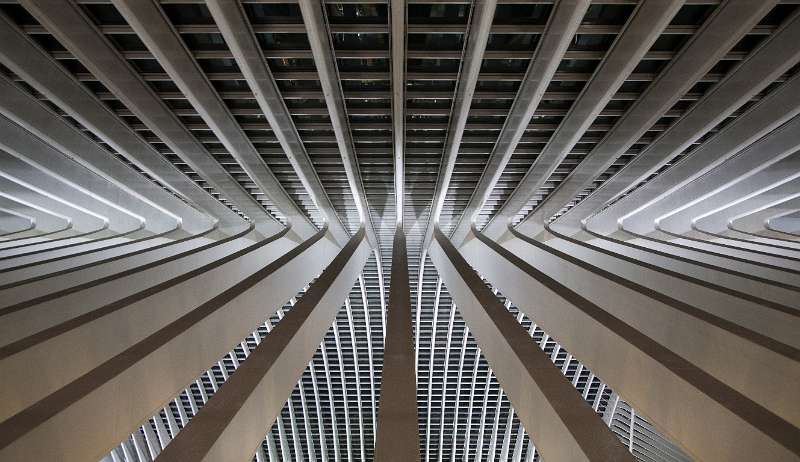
{"left": 0, "top": 227, "right": 327, "bottom": 449}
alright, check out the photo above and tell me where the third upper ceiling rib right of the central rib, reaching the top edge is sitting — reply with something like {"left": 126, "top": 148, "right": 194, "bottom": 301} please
{"left": 482, "top": 1, "right": 683, "bottom": 242}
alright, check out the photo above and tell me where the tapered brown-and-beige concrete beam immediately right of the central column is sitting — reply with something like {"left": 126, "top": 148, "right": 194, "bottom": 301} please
{"left": 429, "top": 229, "right": 634, "bottom": 461}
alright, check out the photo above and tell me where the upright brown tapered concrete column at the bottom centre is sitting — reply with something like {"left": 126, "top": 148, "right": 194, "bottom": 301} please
{"left": 375, "top": 227, "right": 419, "bottom": 462}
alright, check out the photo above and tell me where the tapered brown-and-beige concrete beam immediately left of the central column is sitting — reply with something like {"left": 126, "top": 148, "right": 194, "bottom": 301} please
{"left": 157, "top": 227, "right": 371, "bottom": 462}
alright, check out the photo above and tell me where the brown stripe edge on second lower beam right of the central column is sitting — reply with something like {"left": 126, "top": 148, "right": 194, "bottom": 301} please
{"left": 468, "top": 226, "right": 800, "bottom": 456}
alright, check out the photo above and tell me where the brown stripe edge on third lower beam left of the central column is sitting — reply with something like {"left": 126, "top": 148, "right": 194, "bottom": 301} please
{"left": 0, "top": 224, "right": 289, "bottom": 360}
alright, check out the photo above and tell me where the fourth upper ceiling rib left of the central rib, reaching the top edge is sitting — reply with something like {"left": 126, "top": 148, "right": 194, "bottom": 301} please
{"left": 18, "top": 0, "right": 269, "bottom": 231}
